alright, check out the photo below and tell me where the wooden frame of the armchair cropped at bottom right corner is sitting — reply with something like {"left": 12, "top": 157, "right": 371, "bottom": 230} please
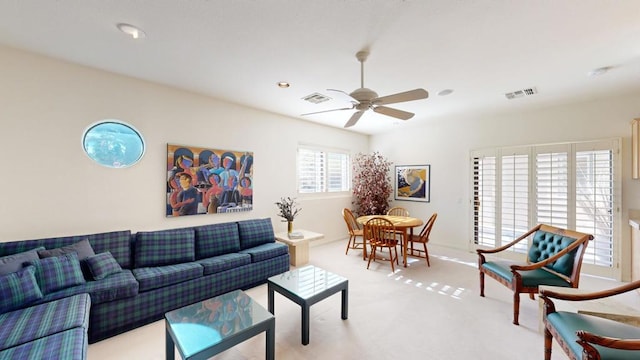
{"left": 540, "top": 280, "right": 640, "bottom": 360}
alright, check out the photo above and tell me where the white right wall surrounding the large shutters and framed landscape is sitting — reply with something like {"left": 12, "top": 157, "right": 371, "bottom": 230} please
{"left": 370, "top": 93, "right": 640, "bottom": 278}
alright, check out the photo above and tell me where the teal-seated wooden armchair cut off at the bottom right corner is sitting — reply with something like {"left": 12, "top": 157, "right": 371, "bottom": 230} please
{"left": 540, "top": 281, "right": 640, "bottom": 360}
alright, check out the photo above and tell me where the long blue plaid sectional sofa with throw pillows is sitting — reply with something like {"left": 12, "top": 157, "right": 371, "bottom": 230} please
{"left": 0, "top": 218, "right": 289, "bottom": 359}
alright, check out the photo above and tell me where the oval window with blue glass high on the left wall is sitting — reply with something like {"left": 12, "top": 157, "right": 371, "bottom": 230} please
{"left": 82, "top": 120, "right": 145, "bottom": 168}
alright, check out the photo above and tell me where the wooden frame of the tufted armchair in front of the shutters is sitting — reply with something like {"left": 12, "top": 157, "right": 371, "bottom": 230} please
{"left": 476, "top": 224, "right": 593, "bottom": 325}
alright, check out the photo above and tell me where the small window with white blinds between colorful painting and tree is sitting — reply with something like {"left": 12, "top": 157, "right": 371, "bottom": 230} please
{"left": 298, "top": 147, "right": 351, "bottom": 193}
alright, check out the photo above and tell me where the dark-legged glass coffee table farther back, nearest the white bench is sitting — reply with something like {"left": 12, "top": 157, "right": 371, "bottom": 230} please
{"left": 267, "top": 265, "right": 349, "bottom": 345}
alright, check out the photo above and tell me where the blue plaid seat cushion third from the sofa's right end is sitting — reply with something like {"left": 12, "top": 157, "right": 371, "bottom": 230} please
{"left": 133, "top": 262, "right": 203, "bottom": 292}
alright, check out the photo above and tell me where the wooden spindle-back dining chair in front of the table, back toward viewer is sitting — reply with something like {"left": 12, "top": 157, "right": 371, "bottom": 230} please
{"left": 364, "top": 217, "right": 398, "bottom": 272}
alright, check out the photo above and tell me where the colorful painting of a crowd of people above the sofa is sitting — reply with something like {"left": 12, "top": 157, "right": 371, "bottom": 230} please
{"left": 166, "top": 144, "right": 253, "bottom": 217}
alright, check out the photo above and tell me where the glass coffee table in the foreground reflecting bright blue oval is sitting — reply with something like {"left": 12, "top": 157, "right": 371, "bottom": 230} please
{"left": 164, "top": 290, "right": 276, "bottom": 360}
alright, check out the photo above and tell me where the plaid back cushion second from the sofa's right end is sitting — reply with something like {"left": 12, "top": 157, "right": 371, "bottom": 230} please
{"left": 195, "top": 222, "right": 240, "bottom": 259}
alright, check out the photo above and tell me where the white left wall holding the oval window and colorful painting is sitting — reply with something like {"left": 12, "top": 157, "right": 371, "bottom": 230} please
{"left": 0, "top": 47, "right": 369, "bottom": 241}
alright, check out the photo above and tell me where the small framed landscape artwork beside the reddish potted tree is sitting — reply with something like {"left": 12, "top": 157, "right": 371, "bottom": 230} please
{"left": 395, "top": 165, "right": 431, "bottom": 202}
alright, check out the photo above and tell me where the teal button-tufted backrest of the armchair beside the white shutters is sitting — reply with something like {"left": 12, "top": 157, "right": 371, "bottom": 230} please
{"left": 529, "top": 230, "right": 578, "bottom": 276}
